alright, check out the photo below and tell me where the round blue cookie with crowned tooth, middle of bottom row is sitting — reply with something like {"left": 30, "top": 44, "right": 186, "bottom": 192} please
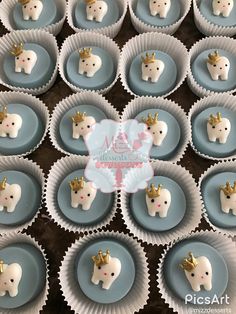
{"left": 75, "top": 238, "right": 135, "bottom": 304}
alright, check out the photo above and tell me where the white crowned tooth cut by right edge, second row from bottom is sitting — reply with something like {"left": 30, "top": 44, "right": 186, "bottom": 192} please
{"left": 220, "top": 181, "right": 236, "bottom": 215}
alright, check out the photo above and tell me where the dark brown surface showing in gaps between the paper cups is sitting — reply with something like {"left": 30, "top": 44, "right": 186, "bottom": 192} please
{"left": 0, "top": 5, "right": 216, "bottom": 314}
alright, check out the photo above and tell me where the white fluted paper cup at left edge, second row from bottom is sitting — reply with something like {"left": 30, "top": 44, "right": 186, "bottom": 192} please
{"left": 0, "top": 156, "right": 45, "bottom": 235}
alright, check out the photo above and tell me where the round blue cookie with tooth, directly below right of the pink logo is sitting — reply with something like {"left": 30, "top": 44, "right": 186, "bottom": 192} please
{"left": 130, "top": 176, "right": 186, "bottom": 232}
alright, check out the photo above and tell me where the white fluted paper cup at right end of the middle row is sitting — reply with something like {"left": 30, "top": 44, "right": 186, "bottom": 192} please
{"left": 188, "top": 93, "right": 236, "bottom": 161}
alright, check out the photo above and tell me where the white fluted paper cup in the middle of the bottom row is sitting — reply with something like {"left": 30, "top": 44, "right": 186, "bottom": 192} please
{"left": 58, "top": 231, "right": 149, "bottom": 314}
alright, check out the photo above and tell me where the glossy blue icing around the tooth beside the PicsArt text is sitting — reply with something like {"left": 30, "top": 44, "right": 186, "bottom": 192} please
{"left": 164, "top": 239, "right": 228, "bottom": 303}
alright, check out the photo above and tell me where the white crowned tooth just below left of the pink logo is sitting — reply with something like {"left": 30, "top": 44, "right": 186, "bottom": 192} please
{"left": 70, "top": 177, "right": 97, "bottom": 210}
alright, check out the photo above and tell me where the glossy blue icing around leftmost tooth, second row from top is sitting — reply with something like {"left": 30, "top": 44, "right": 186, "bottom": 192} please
{"left": 3, "top": 43, "right": 55, "bottom": 88}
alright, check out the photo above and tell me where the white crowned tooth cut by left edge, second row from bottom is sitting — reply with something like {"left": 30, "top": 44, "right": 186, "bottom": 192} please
{"left": 0, "top": 178, "right": 21, "bottom": 213}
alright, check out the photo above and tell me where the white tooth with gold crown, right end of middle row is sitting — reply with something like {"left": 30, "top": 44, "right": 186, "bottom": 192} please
{"left": 207, "top": 112, "right": 231, "bottom": 144}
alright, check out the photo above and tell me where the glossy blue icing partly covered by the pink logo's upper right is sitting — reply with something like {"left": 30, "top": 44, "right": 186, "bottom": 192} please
{"left": 135, "top": 109, "right": 181, "bottom": 160}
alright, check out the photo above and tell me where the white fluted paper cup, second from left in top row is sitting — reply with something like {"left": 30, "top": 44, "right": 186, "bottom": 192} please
{"left": 67, "top": 0, "right": 128, "bottom": 38}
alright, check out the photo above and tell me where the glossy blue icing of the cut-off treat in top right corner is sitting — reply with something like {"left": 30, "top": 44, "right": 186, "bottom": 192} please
{"left": 199, "top": 0, "right": 236, "bottom": 27}
